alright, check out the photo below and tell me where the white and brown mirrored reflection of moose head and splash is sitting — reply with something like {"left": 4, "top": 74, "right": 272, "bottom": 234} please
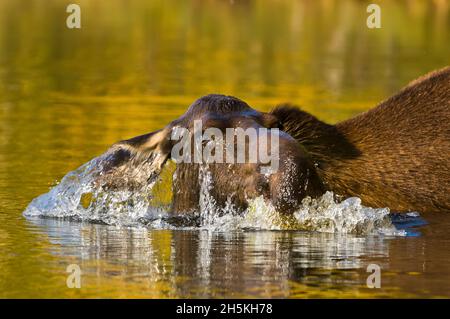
{"left": 28, "top": 219, "right": 389, "bottom": 297}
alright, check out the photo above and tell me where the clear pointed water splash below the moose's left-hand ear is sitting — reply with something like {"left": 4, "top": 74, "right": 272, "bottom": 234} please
{"left": 24, "top": 152, "right": 161, "bottom": 226}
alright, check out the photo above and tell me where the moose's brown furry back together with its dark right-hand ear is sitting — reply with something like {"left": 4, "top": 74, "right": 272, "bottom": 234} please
{"left": 272, "top": 68, "right": 450, "bottom": 212}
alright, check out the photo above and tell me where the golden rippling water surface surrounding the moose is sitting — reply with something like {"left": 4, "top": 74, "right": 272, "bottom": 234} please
{"left": 0, "top": 0, "right": 450, "bottom": 298}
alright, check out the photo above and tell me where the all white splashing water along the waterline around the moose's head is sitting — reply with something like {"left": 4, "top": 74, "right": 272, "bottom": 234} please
{"left": 24, "top": 152, "right": 412, "bottom": 236}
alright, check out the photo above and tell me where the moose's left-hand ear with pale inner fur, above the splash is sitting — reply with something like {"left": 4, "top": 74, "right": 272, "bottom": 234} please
{"left": 111, "top": 127, "right": 173, "bottom": 169}
